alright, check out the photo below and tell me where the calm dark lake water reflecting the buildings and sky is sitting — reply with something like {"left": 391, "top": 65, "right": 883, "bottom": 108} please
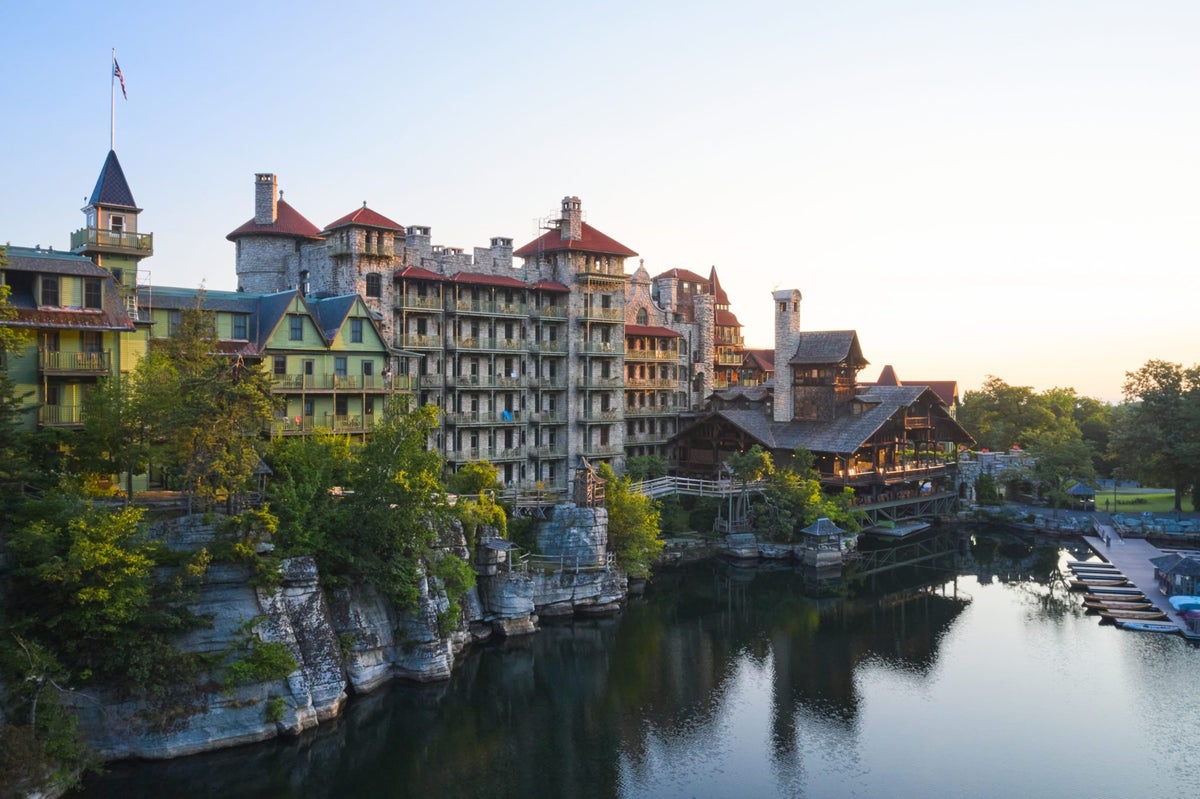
{"left": 72, "top": 527, "right": 1200, "bottom": 799}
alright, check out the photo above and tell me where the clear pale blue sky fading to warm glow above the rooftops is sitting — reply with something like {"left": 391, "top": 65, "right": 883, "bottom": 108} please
{"left": 0, "top": 0, "right": 1200, "bottom": 401}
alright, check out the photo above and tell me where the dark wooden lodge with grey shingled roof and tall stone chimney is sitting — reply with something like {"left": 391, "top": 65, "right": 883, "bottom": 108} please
{"left": 674, "top": 292, "right": 972, "bottom": 518}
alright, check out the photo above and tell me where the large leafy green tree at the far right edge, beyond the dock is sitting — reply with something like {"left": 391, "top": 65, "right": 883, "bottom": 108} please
{"left": 1112, "top": 360, "right": 1200, "bottom": 511}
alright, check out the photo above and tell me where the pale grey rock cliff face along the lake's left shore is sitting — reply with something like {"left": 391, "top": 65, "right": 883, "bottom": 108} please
{"left": 58, "top": 505, "right": 626, "bottom": 759}
